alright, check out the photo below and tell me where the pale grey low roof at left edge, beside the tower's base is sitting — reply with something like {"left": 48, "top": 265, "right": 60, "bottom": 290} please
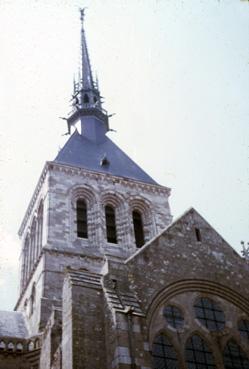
{"left": 0, "top": 311, "right": 28, "bottom": 338}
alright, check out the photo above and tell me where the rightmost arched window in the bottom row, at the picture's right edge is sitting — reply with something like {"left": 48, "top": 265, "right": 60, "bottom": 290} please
{"left": 223, "top": 340, "right": 249, "bottom": 369}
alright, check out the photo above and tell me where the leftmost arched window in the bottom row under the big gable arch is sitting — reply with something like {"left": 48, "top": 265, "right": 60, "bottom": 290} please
{"left": 152, "top": 334, "right": 180, "bottom": 369}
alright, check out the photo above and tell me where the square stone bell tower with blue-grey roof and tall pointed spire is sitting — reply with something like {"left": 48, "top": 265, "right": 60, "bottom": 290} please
{"left": 16, "top": 9, "right": 172, "bottom": 334}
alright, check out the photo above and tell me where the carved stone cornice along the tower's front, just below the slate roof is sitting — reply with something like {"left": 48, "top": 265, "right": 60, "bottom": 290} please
{"left": 48, "top": 162, "right": 171, "bottom": 196}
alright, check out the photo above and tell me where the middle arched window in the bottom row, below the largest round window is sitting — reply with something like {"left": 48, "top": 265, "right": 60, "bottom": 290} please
{"left": 185, "top": 335, "right": 216, "bottom": 369}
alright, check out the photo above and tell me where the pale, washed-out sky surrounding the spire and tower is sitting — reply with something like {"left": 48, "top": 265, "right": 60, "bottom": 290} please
{"left": 0, "top": 0, "right": 249, "bottom": 310}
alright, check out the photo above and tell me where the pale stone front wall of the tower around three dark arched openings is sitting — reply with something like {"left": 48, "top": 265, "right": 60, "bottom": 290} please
{"left": 48, "top": 163, "right": 171, "bottom": 257}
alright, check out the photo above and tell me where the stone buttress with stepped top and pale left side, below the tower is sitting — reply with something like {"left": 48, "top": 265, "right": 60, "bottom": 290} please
{"left": 62, "top": 272, "right": 106, "bottom": 369}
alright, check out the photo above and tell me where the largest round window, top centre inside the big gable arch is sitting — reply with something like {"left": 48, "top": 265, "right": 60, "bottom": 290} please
{"left": 194, "top": 297, "right": 225, "bottom": 332}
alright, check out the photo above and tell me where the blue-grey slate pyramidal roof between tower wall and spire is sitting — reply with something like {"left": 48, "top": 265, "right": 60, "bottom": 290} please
{"left": 54, "top": 131, "right": 157, "bottom": 184}
